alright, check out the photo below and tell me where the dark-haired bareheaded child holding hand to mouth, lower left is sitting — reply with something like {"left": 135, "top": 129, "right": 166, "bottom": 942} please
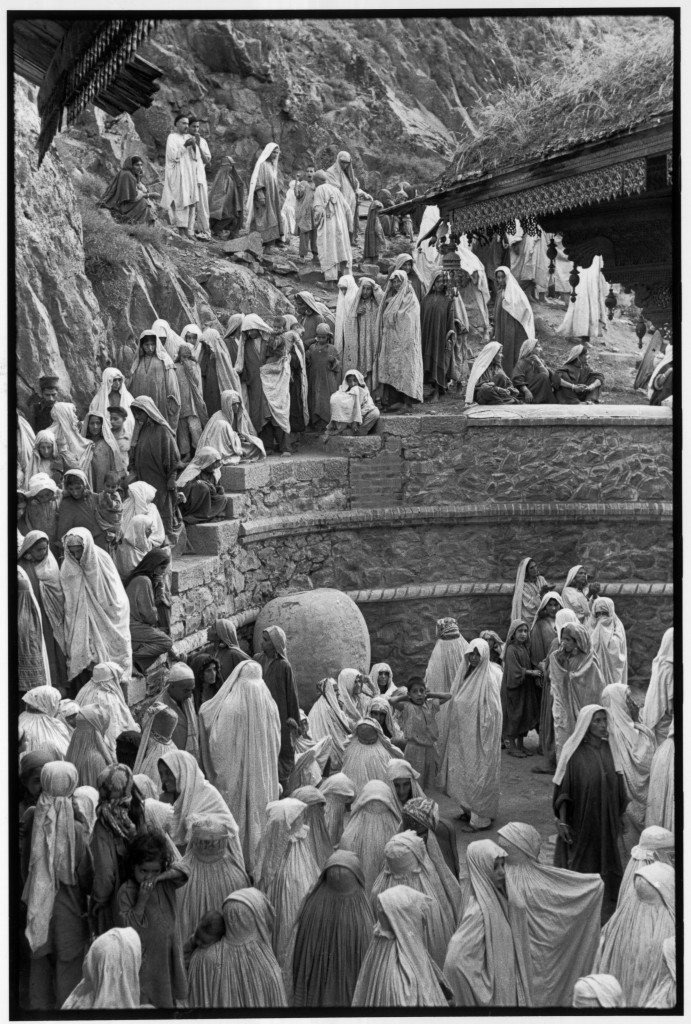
{"left": 118, "top": 833, "right": 187, "bottom": 1008}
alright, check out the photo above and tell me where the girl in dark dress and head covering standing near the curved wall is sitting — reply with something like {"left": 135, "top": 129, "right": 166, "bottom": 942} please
{"left": 502, "top": 618, "right": 539, "bottom": 758}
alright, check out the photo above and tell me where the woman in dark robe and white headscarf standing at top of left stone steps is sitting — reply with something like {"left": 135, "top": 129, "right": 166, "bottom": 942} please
{"left": 130, "top": 396, "right": 181, "bottom": 546}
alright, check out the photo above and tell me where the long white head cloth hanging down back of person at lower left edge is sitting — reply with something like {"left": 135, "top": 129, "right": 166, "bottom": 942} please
{"left": 21, "top": 761, "right": 79, "bottom": 952}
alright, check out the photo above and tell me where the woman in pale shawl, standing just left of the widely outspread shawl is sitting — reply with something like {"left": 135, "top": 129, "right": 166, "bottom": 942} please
{"left": 444, "top": 839, "right": 534, "bottom": 1007}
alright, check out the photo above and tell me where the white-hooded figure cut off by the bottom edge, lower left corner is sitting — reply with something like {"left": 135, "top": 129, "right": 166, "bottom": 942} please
{"left": 61, "top": 928, "right": 141, "bottom": 1011}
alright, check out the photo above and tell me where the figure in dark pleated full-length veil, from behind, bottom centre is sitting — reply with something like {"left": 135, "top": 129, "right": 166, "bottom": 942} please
{"left": 293, "top": 850, "right": 375, "bottom": 1007}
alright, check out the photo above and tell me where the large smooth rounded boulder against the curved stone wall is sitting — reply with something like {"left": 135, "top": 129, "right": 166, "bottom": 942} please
{"left": 254, "top": 588, "right": 371, "bottom": 711}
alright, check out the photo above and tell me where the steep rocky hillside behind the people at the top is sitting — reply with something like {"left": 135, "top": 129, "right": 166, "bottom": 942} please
{"left": 14, "top": 17, "right": 634, "bottom": 413}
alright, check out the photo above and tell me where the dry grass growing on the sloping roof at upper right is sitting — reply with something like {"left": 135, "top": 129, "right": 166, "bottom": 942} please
{"left": 443, "top": 17, "right": 674, "bottom": 183}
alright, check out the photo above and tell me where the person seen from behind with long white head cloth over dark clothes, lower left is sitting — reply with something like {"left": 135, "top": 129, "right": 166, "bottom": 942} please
{"left": 21, "top": 761, "right": 93, "bottom": 1011}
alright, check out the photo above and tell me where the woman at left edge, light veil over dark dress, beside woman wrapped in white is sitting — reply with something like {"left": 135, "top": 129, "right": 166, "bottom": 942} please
{"left": 17, "top": 529, "right": 68, "bottom": 689}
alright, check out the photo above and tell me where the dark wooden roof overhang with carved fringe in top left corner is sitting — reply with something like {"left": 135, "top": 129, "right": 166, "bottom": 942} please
{"left": 9, "top": 15, "right": 163, "bottom": 163}
